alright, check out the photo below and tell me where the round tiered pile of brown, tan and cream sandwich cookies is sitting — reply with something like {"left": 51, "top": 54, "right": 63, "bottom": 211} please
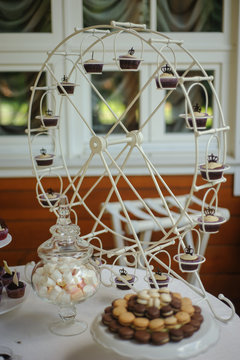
{"left": 102, "top": 288, "right": 203, "bottom": 345}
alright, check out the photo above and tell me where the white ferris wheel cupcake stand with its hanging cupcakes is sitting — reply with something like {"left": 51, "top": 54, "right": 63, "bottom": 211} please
{"left": 27, "top": 21, "right": 235, "bottom": 340}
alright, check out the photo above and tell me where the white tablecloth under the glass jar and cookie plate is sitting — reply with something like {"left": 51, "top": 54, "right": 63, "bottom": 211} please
{"left": 0, "top": 267, "right": 240, "bottom": 360}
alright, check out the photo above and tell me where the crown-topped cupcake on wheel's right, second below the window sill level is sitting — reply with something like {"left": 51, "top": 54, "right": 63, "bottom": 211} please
{"left": 197, "top": 207, "right": 226, "bottom": 234}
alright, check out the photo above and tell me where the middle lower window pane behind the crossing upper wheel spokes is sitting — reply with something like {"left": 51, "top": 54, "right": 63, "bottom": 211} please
{"left": 92, "top": 71, "right": 139, "bottom": 134}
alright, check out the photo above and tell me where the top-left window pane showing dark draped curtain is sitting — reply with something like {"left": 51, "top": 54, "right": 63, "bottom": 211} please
{"left": 0, "top": 0, "right": 51, "bottom": 33}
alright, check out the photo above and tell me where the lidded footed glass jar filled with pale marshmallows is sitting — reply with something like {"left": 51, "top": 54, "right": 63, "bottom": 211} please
{"left": 28, "top": 197, "right": 100, "bottom": 336}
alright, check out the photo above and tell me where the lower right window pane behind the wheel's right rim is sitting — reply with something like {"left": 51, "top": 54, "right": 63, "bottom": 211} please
{"left": 164, "top": 70, "right": 214, "bottom": 133}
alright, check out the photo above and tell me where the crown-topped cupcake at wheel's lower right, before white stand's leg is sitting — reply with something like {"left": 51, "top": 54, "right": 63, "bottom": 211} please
{"left": 173, "top": 245, "right": 206, "bottom": 272}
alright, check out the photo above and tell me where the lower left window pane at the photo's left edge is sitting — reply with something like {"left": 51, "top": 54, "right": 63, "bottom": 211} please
{"left": 0, "top": 72, "right": 46, "bottom": 135}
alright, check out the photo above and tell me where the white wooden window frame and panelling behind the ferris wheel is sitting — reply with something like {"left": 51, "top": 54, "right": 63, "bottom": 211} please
{"left": 0, "top": 0, "right": 240, "bottom": 197}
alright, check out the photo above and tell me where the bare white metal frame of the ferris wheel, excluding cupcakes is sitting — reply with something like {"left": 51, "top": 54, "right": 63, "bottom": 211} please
{"left": 28, "top": 22, "right": 234, "bottom": 322}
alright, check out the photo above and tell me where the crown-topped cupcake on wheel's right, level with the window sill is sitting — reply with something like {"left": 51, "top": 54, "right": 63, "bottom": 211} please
{"left": 199, "top": 154, "right": 229, "bottom": 181}
